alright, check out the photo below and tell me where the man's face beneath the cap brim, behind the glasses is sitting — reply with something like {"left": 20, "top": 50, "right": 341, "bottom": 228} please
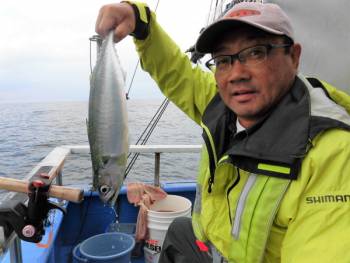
{"left": 212, "top": 27, "right": 301, "bottom": 128}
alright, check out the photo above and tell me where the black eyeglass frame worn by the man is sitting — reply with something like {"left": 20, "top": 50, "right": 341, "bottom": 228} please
{"left": 205, "top": 43, "right": 293, "bottom": 71}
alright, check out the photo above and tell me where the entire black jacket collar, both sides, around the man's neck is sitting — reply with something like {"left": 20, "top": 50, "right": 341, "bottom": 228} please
{"left": 203, "top": 77, "right": 334, "bottom": 179}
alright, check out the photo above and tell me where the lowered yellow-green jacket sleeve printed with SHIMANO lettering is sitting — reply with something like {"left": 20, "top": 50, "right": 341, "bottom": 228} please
{"left": 277, "top": 129, "right": 350, "bottom": 263}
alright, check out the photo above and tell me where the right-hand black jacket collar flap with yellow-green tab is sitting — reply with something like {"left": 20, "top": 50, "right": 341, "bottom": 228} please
{"left": 227, "top": 78, "right": 310, "bottom": 179}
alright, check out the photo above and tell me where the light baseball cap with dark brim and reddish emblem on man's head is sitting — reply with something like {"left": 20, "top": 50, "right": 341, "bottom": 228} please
{"left": 196, "top": 2, "right": 294, "bottom": 53}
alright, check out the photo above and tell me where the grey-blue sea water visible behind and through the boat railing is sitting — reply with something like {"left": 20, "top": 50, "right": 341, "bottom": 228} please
{"left": 0, "top": 100, "right": 202, "bottom": 197}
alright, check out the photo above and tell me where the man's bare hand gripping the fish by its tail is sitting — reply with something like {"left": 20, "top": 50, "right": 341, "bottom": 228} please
{"left": 95, "top": 3, "right": 136, "bottom": 42}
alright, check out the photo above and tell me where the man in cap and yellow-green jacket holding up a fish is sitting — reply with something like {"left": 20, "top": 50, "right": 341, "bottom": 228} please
{"left": 96, "top": 3, "right": 350, "bottom": 263}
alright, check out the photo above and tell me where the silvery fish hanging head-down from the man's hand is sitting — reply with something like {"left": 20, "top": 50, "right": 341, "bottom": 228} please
{"left": 87, "top": 32, "right": 129, "bottom": 207}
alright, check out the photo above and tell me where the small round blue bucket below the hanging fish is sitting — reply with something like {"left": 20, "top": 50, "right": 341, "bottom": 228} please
{"left": 73, "top": 232, "right": 135, "bottom": 263}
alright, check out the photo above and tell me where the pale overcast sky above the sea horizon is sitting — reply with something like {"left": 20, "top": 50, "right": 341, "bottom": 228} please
{"left": 0, "top": 0, "right": 210, "bottom": 102}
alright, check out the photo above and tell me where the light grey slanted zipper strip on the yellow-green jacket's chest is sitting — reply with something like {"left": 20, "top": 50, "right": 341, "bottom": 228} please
{"left": 232, "top": 173, "right": 257, "bottom": 239}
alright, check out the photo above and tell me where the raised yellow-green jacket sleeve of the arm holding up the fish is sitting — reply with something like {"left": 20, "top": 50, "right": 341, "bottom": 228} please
{"left": 134, "top": 7, "right": 217, "bottom": 124}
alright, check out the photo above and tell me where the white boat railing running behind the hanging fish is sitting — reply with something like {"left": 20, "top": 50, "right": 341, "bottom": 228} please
{"left": 0, "top": 145, "right": 202, "bottom": 263}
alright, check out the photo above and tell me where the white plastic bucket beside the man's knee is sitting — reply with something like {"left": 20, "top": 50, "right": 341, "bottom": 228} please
{"left": 146, "top": 195, "right": 192, "bottom": 263}
